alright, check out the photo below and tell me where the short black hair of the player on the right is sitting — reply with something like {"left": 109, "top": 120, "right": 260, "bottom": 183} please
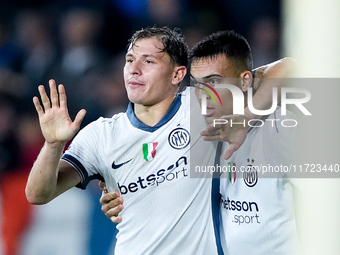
{"left": 190, "top": 30, "right": 253, "bottom": 72}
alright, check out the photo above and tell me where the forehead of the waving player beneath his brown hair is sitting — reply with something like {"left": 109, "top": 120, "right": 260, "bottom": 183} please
{"left": 126, "top": 37, "right": 167, "bottom": 58}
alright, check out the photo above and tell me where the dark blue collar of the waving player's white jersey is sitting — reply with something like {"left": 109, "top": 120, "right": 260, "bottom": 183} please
{"left": 126, "top": 94, "right": 182, "bottom": 132}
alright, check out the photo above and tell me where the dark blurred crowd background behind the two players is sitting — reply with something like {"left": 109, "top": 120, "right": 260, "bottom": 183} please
{"left": 0, "top": 0, "right": 282, "bottom": 255}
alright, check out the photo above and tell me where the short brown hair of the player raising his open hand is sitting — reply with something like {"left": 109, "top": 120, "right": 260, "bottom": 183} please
{"left": 128, "top": 26, "right": 189, "bottom": 67}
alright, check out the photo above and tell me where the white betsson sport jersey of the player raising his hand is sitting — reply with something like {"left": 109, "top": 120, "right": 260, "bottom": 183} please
{"left": 62, "top": 89, "right": 222, "bottom": 255}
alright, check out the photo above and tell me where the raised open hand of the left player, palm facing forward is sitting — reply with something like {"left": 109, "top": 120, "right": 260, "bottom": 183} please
{"left": 33, "top": 79, "right": 86, "bottom": 143}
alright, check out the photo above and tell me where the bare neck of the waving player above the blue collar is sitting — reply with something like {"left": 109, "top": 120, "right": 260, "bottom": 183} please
{"left": 134, "top": 97, "right": 175, "bottom": 127}
